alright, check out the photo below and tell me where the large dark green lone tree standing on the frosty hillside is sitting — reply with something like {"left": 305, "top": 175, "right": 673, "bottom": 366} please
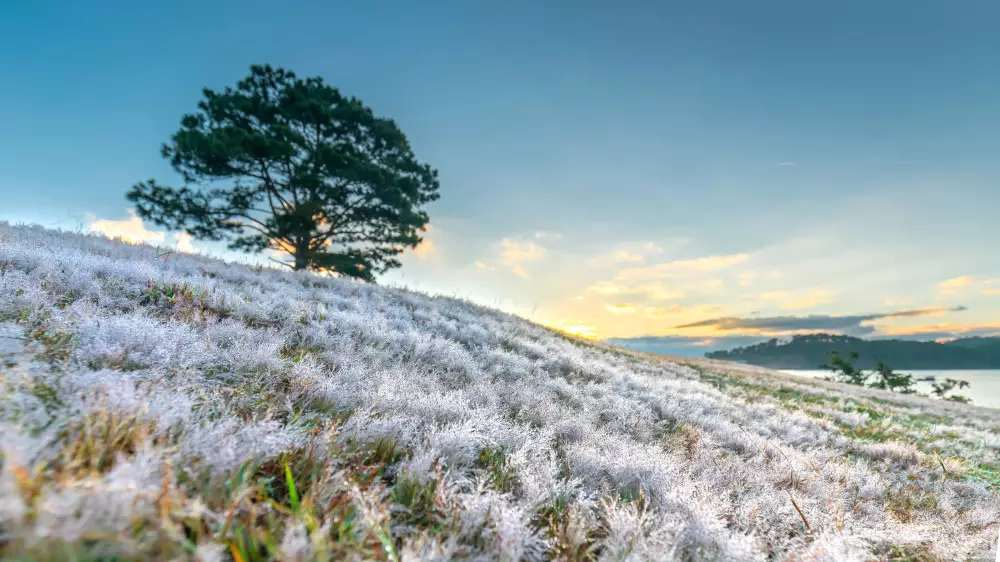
{"left": 127, "top": 66, "right": 439, "bottom": 281}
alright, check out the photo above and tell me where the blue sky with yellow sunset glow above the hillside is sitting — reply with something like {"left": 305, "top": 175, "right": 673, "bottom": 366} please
{"left": 0, "top": 0, "right": 1000, "bottom": 355}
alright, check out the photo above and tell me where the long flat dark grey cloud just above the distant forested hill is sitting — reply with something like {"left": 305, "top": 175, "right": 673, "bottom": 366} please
{"left": 676, "top": 306, "right": 966, "bottom": 334}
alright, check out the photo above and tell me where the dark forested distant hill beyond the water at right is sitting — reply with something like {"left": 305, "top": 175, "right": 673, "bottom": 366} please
{"left": 705, "top": 334, "right": 1000, "bottom": 369}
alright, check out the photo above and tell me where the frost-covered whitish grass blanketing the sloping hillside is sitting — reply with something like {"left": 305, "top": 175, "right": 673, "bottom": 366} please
{"left": 0, "top": 224, "right": 1000, "bottom": 562}
